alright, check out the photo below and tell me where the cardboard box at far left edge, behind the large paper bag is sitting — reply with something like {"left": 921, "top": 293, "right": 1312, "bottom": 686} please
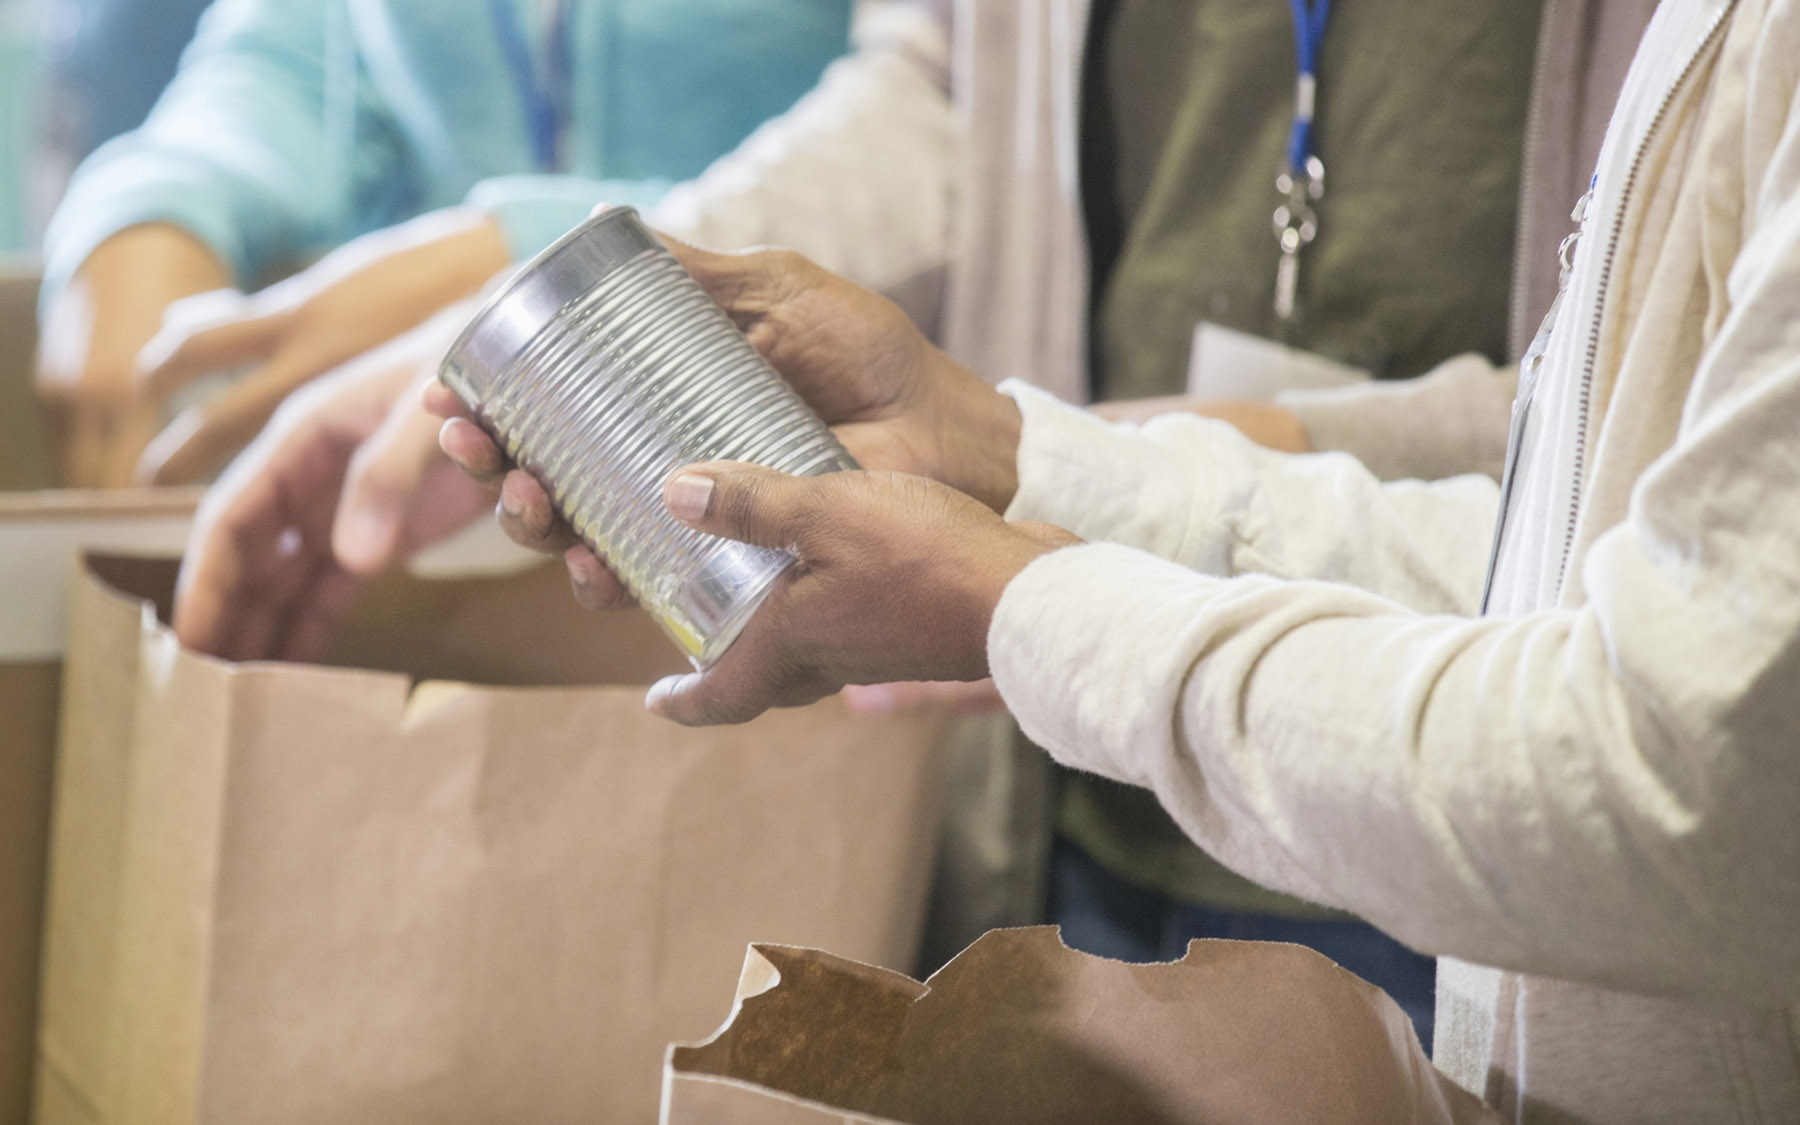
{"left": 0, "top": 270, "right": 198, "bottom": 1125}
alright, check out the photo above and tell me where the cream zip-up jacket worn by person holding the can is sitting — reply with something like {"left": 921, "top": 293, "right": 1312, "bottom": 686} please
{"left": 988, "top": 0, "right": 1800, "bottom": 1121}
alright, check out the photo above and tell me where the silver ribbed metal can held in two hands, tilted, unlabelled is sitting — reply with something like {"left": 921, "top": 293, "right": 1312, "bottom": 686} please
{"left": 439, "top": 207, "right": 857, "bottom": 668}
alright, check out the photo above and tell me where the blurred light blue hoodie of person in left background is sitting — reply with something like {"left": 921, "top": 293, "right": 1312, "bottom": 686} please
{"left": 45, "top": 0, "right": 851, "bottom": 307}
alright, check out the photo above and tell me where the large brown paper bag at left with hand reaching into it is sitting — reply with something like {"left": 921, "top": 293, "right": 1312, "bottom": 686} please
{"left": 38, "top": 560, "right": 943, "bottom": 1125}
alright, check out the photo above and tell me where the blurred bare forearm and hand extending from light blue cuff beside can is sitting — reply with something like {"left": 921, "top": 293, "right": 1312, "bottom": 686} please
{"left": 135, "top": 209, "right": 508, "bottom": 484}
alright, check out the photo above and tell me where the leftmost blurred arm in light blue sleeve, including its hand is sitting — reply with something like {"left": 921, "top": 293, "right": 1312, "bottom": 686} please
{"left": 38, "top": 0, "right": 406, "bottom": 486}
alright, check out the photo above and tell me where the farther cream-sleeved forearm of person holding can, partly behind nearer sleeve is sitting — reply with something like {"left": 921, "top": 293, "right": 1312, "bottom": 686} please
{"left": 1008, "top": 387, "right": 1498, "bottom": 612}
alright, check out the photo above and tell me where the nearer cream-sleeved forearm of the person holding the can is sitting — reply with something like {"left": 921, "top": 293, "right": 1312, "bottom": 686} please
{"left": 988, "top": 547, "right": 1800, "bottom": 1003}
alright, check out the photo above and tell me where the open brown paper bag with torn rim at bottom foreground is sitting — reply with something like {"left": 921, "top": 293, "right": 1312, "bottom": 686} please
{"left": 662, "top": 927, "right": 1498, "bottom": 1125}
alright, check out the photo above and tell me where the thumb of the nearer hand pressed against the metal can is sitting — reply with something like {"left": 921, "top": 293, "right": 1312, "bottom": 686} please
{"left": 662, "top": 461, "right": 824, "bottom": 549}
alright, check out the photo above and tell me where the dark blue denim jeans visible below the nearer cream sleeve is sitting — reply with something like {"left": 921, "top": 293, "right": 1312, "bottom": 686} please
{"left": 1049, "top": 837, "right": 1436, "bottom": 1055}
